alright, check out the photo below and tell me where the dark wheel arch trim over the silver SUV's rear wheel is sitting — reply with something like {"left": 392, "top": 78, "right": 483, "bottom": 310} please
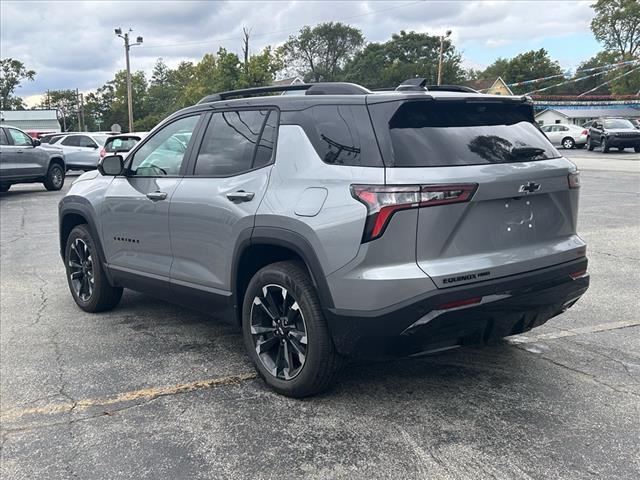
{"left": 230, "top": 227, "right": 333, "bottom": 322}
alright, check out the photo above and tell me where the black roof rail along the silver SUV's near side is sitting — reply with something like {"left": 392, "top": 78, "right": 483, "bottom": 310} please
{"left": 198, "top": 82, "right": 371, "bottom": 104}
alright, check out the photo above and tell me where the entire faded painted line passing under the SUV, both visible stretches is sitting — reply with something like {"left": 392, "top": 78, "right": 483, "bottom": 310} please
{"left": 0, "top": 320, "right": 640, "bottom": 423}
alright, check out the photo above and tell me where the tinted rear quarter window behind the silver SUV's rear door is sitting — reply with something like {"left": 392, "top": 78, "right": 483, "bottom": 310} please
{"left": 281, "top": 105, "right": 383, "bottom": 167}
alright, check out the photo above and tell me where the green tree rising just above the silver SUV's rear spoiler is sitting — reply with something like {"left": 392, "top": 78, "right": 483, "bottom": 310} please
{"left": 480, "top": 48, "right": 562, "bottom": 94}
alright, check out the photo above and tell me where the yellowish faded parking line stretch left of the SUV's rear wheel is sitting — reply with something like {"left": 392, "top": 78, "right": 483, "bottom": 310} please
{"left": 0, "top": 372, "right": 257, "bottom": 423}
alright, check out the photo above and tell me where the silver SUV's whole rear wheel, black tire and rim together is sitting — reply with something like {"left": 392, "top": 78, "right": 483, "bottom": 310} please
{"left": 242, "top": 262, "right": 342, "bottom": 398}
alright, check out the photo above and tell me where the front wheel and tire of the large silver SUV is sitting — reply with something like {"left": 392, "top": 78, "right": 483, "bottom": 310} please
{"left": 64, "top": 225, "right": 122, "bottom": 312}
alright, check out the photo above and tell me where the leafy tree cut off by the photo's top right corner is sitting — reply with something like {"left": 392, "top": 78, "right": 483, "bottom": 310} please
{"left": 591, "top": 0, "right": 640, "bottom": 58}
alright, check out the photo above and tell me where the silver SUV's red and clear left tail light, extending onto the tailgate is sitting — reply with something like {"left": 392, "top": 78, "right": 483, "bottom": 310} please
{"left": 351, "top": 183, "right": 478, "bottom": 243}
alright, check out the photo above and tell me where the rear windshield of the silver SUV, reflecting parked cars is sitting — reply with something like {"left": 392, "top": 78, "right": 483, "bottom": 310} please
{"left": 370, "top": 101, "right": 560, "bottom": 167}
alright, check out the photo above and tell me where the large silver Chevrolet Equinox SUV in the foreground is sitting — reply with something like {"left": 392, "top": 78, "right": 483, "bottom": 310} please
{"left": 60, "top": 80, "right": 589, "bottom": 397}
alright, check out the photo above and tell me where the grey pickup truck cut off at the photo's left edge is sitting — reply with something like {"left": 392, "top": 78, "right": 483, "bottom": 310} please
{"left": 0, "top": 126, "right": 65, "bottom": 192}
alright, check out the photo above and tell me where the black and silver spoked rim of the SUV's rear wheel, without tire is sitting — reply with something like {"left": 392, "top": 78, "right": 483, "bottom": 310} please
{"left": 250, "top": 284, "right": 307, "bottom": 380}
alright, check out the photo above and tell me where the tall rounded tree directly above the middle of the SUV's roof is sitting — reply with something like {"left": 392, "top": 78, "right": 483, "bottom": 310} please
{"left": 279, "top": 22, "right": 364, "bottom": 82}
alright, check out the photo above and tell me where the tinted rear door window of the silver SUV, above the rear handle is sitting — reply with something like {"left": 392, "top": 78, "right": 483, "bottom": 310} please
{"left": 194, "top": 110, "right": 273, "bottom": 177}
